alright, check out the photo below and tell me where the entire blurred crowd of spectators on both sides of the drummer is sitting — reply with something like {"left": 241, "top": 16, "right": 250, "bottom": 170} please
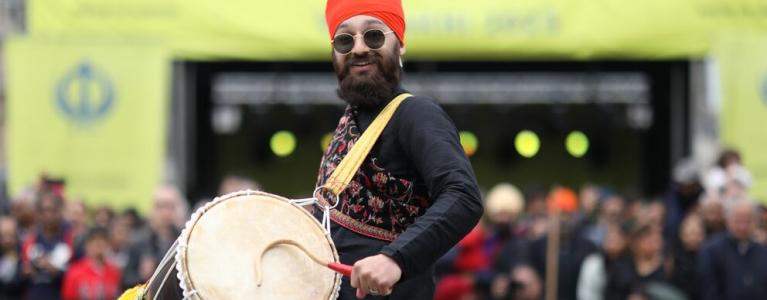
{"left": 0, "top": 151, "right": 767, "bottom": 300}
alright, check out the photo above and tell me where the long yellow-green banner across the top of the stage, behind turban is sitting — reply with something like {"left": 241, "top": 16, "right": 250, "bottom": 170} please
{"left": 28, "top": 0, "right": 767, "bottom": 60}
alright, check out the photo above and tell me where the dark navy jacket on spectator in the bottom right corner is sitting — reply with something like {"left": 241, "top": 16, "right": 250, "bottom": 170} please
{"left": 698, "top": 233, "right": 767, "bottom": 300}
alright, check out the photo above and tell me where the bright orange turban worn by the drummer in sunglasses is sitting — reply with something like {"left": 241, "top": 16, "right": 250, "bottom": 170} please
{"left": 325, "top": 0, "right": 405, "bottom": 45}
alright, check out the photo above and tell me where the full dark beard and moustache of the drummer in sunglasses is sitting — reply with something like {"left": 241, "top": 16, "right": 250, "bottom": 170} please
{"left": 333, "top": 47, "right": 401, "bottom": 108}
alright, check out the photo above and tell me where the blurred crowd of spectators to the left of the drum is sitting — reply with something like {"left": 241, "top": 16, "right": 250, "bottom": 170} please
{"left": 0, "top": 178, "right": 195, "bottom": 300}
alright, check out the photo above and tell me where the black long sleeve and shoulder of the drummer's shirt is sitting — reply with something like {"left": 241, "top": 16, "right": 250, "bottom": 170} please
{"left": 354, "top": 90, "right": 483, "bottom": 279}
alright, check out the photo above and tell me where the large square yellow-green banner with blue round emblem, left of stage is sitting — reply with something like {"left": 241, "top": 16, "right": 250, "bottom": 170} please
{"left": 5, "top": 39, "right": 170, "bottom": 212}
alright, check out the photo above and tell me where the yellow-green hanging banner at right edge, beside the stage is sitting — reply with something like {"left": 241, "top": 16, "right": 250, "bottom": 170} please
{"left": 713, "top": 35, "right": 767, "bottom": 203}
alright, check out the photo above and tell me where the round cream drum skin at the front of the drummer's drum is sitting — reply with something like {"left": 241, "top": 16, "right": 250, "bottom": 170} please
{"left": 176, "top": 191, "right": 341, "bottom": 300}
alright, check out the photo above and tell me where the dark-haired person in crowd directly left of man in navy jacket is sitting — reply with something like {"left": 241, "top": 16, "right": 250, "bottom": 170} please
{"left": 671, "top": 214, "right": 706, "bottom": 299}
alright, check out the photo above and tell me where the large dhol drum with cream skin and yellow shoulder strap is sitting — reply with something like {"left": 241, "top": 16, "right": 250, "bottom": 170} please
{"left": 120, "top": 93, "right": 411, "bottom": 300}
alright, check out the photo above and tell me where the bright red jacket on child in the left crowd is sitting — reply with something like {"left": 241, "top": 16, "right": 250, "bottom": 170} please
{"left": 61, "top": 257, "right": 121, "bottom": 300}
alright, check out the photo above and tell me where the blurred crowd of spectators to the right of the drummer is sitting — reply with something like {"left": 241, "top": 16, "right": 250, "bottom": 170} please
{"left": 435, "top": 150, "right": 767, "bottom": 300}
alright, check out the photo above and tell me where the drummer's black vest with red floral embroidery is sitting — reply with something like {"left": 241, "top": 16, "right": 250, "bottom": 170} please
{"left": 317, "top": 107, "right": 431, "bottom": 241}
